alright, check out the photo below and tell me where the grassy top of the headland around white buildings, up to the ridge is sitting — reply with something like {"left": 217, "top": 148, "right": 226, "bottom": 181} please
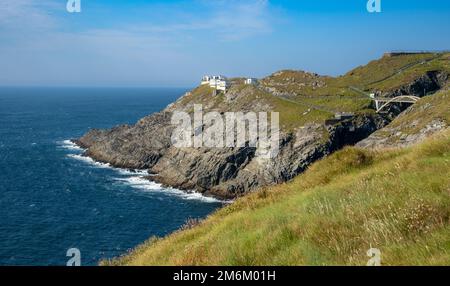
{"left": 171, "top": 53, "right": 450, "bottom": 131}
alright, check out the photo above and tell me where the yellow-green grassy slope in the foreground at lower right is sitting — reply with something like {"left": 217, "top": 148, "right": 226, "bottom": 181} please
{"left": 103, "top": 131, "right": 450, "bottom": 265}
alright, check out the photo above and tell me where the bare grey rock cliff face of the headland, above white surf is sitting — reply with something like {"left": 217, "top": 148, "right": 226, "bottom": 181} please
{"left": 76, "top": 107, "right": 385, "bottom": 198}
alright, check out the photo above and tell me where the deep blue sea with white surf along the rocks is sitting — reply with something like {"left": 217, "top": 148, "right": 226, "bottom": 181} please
{"left": 0, "top": 87, "right": 223, "bottom": 265}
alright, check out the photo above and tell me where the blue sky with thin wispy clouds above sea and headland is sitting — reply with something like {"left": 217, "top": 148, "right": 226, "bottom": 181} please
{"left": 0, "top": 0, "right": 450, "bottom": 87}
